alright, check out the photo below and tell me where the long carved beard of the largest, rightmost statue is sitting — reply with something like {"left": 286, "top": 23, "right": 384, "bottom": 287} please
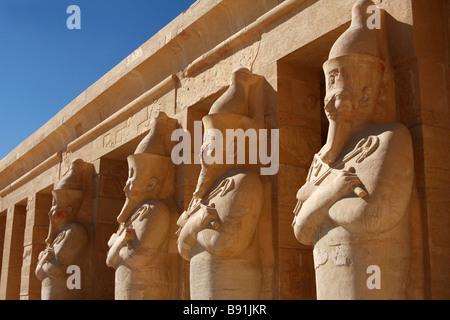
{"left": 320, "top": 119, "right": 352, "bottom": 164}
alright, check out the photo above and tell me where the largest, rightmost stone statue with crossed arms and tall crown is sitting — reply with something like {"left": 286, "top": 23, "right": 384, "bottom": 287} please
{"left": 293, "top": 0, "right": 414, "bottom": 299}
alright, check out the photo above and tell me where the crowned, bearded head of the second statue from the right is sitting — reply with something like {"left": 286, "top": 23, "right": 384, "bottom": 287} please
{"left": 194, "top": 68, "right": 261, "bottom": 198}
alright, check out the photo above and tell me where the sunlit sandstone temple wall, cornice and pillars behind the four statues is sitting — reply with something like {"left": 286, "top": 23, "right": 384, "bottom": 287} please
{"left": 0, "top": 0, "right": 450, "bottom": 299}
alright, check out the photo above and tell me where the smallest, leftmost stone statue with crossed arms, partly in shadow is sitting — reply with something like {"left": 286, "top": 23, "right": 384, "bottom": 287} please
{"left": 35, "top": 159, "right": 92, "bottom": 300}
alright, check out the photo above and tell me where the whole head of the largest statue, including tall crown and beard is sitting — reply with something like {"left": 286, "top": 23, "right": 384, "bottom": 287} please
{"left": 322, "top": 0, "right": 386, "bottom": 162}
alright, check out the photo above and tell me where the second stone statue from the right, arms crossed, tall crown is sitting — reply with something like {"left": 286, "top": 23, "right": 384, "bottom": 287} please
{"left": 177, "top": 68, "right": 271, "bottom": 300}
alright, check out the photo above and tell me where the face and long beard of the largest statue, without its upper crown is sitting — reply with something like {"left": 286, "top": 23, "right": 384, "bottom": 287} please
{"left": 320, "top": 55, "right": 384, "bottom": 164}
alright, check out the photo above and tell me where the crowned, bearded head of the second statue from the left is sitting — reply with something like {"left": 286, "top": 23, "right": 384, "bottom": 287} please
{"left": 117, "top": 112, "right": 175, "bottom": 223}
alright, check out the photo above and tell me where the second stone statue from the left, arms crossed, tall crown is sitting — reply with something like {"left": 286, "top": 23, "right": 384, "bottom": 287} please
{"left": 106, "top": 112, "right": 176, "bottom": 300}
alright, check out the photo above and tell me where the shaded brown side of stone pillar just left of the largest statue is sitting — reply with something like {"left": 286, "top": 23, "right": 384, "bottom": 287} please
{"left": 277, "top": 63, "right": 322, "bottom": 300}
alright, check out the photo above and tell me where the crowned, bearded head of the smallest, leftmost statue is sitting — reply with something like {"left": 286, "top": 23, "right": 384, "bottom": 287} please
{"left": 46, "top": 159, "right": 90, "bottom": 244}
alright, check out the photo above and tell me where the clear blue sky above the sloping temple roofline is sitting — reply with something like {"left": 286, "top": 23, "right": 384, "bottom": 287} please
{"left": 0, "top": 0, "right": 195, "bottom": 160}
